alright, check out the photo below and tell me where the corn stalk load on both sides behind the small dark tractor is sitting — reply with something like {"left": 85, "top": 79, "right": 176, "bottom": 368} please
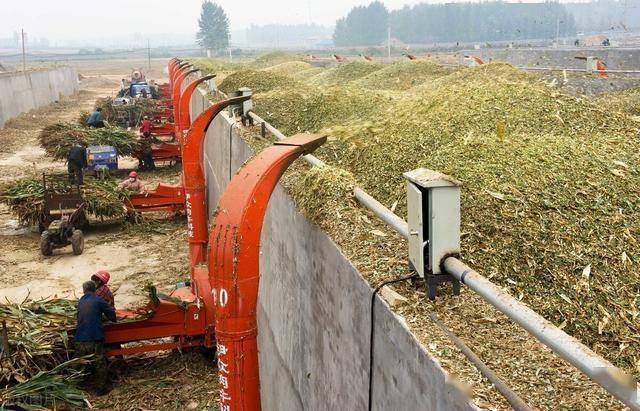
{"left": 0, "top": 177, "right": 128, "bottom": 226}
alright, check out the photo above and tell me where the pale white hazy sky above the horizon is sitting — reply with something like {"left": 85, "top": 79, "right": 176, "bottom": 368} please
{"left": 0, "top": 0, "right": 430, "bottom": 41}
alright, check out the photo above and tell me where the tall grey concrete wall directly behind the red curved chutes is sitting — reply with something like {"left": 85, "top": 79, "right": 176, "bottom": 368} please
{"left": 192, "top": 93, "right": 475, "bottom": 411}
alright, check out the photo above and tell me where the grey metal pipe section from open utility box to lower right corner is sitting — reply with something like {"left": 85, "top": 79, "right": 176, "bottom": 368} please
{"left": 444, "top": 257, "right": 640, "bottom": 410}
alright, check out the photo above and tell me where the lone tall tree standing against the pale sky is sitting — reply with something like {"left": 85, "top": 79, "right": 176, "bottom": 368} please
{"left": 196, "top": 0, "right": 229, "bottom": 51}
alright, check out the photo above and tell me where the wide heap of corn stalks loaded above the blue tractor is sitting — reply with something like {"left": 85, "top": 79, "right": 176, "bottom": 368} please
{"left": 40, "top": 123, "right": 138, "bottom": 160}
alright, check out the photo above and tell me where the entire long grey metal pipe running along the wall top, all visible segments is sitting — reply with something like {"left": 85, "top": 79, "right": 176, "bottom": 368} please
{"left": 249, "top": 112, "right": 640, "bottom": 410}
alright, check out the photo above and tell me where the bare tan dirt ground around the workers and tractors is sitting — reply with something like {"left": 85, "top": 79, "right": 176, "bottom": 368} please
{"left": 0, "top": 60, "right": 217, "bottom": 410}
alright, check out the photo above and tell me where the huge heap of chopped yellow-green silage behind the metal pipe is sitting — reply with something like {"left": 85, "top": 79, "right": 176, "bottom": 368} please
{"left": 216, "top": 57, "right": 640, "bottom": 375}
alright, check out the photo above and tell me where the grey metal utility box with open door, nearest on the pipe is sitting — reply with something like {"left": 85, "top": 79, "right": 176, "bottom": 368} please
{"left": 404, "top": 168, "right": 460, "bottom": 298}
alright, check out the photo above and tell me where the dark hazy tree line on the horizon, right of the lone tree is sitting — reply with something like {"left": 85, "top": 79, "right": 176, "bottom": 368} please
{"left": 333, "top": 1, "right": 576, "bottom": 46}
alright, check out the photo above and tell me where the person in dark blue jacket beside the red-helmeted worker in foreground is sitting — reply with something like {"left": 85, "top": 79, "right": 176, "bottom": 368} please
{"left": 75, "top": 281, "right": 116, "bottom": 395}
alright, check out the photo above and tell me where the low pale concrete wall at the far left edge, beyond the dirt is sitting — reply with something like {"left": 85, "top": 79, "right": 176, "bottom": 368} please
{"left": 0, "top": 67, "right": 78, "bottom": 128}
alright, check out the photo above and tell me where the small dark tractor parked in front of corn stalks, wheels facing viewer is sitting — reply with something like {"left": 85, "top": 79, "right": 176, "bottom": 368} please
{"left": 38, "top": 173, "right": 88, "bottom": 256}
